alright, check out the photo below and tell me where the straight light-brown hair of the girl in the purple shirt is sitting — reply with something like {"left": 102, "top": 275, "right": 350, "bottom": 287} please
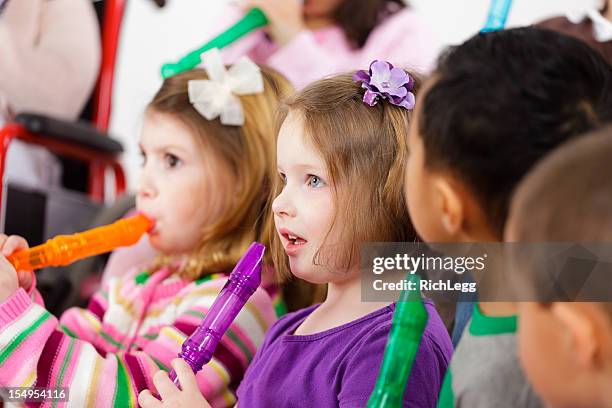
{"left": 270, "top": 74, "right": 420, "bottom": 284}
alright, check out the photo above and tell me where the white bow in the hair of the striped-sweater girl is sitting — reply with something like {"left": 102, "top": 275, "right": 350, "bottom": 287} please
{"left": 187, "top": 48, "right": 264, "bottom": 126}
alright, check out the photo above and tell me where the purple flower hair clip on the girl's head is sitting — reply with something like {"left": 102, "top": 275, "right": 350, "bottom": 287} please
{"left": 353, "top": 60, "right": 415, "bottom": 110}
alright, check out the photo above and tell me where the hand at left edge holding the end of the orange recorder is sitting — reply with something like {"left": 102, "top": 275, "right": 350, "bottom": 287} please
{"left": 0, "top": 234, "right": 32, "bottom": 302}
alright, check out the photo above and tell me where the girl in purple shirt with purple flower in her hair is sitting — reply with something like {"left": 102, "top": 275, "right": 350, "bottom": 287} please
{"left": 141, "top": 61, "right": 452, "bottom": 407}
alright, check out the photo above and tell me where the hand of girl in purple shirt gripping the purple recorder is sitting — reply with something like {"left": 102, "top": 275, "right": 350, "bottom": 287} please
{"left": 138, "top": 358, "right": 210, "bottom": 408}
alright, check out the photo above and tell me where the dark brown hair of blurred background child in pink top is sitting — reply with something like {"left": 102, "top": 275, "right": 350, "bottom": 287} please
{"left": 334, "top": 0, "right": 406, "bottom": 48}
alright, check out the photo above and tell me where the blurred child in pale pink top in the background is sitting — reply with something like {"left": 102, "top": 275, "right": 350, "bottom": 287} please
{"left": 221, "top": 0, "right": 436, "bottom": 88}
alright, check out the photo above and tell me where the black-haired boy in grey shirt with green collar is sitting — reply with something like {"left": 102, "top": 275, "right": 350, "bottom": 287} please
{"left": 405, "top": 27, "right": 612, "bottom": 407}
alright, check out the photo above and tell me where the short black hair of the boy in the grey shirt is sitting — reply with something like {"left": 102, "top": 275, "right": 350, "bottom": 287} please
{"left": 418, "top": 27, "right": 612, "bottom": 238}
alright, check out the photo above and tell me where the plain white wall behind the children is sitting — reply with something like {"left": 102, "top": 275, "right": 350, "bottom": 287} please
{"left": 110, "top": 0, "right": 599, "bottom": 188}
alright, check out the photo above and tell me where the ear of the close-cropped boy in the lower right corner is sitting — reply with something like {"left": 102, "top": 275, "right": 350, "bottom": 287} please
{"left": 551, "top": 302, "right": 601, "bottom": 368}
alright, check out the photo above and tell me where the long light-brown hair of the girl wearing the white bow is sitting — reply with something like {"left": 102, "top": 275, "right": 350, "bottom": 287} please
{"left": 148, "top": 67, "right": 293, "bottom": 279}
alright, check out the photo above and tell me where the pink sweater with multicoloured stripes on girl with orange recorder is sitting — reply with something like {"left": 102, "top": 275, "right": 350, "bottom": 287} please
{"left": 0, "top": 268, "right": 276, "bottom": 407}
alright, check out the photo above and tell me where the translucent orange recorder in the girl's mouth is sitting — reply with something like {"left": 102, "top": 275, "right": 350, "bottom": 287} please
{"left": 7, "top": 214, "right": 153, "bottom": 270}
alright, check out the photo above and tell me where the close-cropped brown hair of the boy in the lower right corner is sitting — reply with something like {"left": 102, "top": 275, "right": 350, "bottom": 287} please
{"left": 507, "top": 127, "right": 612, "bottom": 308}
